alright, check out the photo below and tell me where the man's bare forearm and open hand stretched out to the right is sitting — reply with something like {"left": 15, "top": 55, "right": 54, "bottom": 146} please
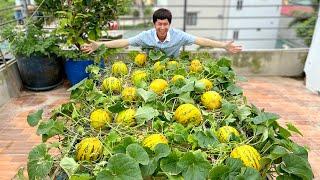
{"left": 195, "top": 37, "right": 242, "bottom": 53}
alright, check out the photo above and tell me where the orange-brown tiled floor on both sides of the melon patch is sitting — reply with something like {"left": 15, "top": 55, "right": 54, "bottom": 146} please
{"left": 0, "top": 77, "right": 320, "bottom": 179}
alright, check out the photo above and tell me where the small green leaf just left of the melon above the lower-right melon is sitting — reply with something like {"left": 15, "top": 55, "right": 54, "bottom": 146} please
{"left": 196, "top": 130, "right": 219, "bottom": 148}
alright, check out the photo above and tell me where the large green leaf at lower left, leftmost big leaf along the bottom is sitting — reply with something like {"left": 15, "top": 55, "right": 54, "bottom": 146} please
{"left": 27, "top": 143, "right": 53, "bottom": 180}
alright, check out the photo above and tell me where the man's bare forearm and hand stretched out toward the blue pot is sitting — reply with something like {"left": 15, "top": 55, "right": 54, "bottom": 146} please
{"left": 81, "top": 39, "right": 129, "bottom": 54}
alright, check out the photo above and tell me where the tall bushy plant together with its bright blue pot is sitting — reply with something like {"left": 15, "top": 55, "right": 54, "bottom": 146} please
{"left": 36, "top": 0, "right": 131, "bottom": 85}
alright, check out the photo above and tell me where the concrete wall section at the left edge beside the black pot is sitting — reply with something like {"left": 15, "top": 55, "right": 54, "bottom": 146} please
{"left": 0, "top": 59, "right": 22, "bottom": 107}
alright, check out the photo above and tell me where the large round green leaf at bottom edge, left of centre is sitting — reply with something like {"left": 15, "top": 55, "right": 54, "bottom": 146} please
{"left": 97, "top": 154, "right": 142, "bottom": 180}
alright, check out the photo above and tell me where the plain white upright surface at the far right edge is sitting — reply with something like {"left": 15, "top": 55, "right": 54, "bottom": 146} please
{"left": 304, "top": 4, "right": 320, "bottom": 95}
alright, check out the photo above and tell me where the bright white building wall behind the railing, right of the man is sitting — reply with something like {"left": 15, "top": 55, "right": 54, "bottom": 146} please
{"left": 227, "top": 0, "right": 281, "bottom": 49}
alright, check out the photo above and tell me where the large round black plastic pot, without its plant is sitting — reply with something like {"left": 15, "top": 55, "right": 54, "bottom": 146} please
{"left": 17, "top": 56, "right": 63, "bottom": 91}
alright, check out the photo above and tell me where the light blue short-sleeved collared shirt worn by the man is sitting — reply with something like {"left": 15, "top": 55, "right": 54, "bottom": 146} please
{"left": 128, "top": 28, "right": 196, "bottom": 57}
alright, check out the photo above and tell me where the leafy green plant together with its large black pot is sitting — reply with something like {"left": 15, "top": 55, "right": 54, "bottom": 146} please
{"left": 1, "top": 23, "right": 63, "bottom": 91}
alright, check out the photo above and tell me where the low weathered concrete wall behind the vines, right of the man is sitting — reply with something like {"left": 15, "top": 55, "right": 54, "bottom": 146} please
{"left": 204, "top": 48, "right": 308, "bottom": 77}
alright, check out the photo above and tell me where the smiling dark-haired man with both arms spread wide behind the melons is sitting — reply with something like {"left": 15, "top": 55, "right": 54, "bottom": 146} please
{"left": 81, "top": 8, "right": 242, "bottom": 57}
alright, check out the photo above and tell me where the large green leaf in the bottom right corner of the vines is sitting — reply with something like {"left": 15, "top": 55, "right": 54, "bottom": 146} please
{"left": 281, "top": 154, "right": 313, "bottom": 180}
